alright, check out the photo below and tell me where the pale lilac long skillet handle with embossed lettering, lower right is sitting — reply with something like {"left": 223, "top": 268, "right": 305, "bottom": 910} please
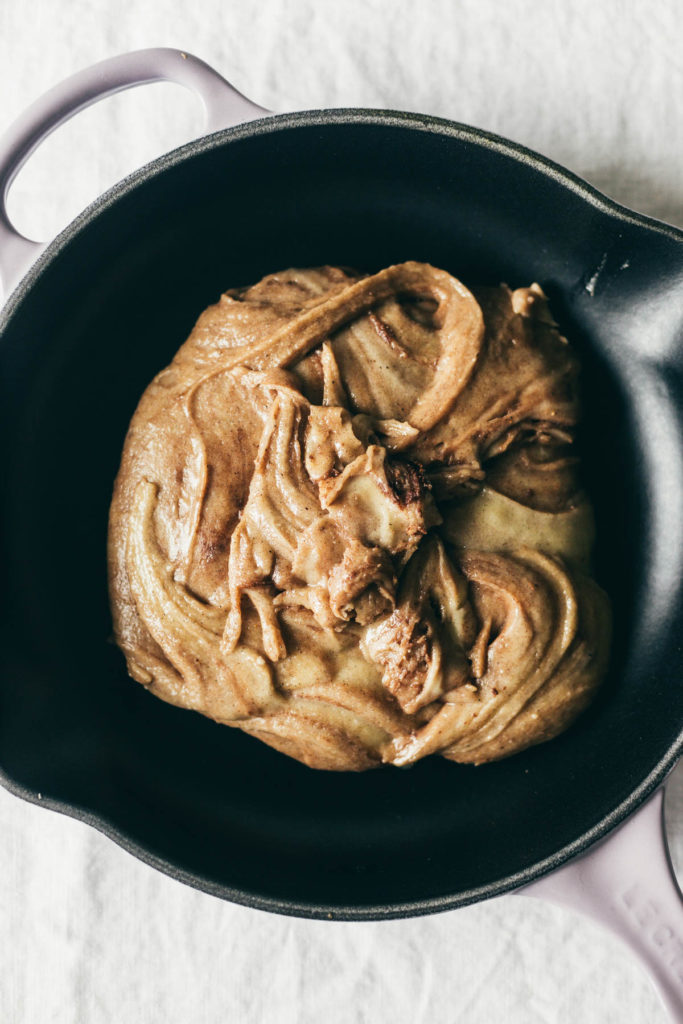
{"left": 518, "top": 787, "right": 683, "bottom": 1021}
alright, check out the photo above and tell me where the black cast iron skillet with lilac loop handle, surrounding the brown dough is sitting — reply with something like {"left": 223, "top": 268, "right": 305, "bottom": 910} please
{"left": 0, "top": 51, "right": 683, "bottom": 1015}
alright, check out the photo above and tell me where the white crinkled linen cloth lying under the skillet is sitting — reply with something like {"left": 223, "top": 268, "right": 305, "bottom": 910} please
{"left": 0, "top": 0, "right": 683, "bottom": 1024}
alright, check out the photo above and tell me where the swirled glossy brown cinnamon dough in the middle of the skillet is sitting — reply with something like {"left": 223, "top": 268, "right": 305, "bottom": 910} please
{"left": 109, "top": 262, "right": 609, "bottom": 771}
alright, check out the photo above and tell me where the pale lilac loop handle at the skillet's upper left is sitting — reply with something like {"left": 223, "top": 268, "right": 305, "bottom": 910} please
{"left": 0, "top": 48, "right": 269, "bottom": 297}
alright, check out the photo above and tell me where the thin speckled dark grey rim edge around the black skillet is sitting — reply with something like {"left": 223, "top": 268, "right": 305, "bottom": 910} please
{"left": 0, "top": 108, "right": 683, "bottom": 921}
